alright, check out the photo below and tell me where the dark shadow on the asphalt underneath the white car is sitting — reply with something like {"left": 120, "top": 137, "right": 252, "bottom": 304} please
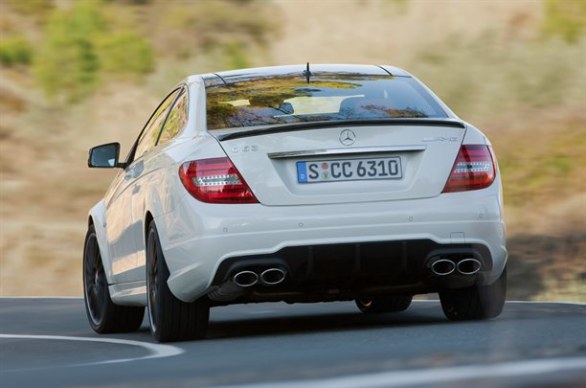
{"left": 129, "top": 301, "right": 548, "bottom": 341}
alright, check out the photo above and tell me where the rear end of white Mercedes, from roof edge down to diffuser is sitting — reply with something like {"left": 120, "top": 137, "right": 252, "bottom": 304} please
{"left": 166, "top": 65, "right": 507, "bottom": 310}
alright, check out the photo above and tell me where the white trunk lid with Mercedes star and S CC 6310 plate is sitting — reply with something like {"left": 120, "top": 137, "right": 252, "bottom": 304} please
{"left": 212, "top": 120, "right": 465, "bottom": 206}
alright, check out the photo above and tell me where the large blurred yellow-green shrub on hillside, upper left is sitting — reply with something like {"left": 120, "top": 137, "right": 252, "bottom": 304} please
{"left": 33, "top": 0, "right": 155, "bottom": 102}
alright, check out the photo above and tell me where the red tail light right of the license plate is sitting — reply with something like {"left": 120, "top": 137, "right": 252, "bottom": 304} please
{"left": 443, "top": 145, "right": 496, "bottom": 193}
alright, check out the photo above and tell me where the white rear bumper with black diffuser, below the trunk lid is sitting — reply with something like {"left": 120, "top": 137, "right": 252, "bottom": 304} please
{"left": 156, "top": 185, "right": 507, "bottom": 301}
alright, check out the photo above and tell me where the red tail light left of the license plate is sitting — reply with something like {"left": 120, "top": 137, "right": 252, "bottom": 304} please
{"left": 179, "top": 158, "right": 258, "bottom": 203}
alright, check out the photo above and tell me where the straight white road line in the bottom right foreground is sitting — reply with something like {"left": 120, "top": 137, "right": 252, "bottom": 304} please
{"left": 235, "top": 358, "right": 586, "bottom": 388}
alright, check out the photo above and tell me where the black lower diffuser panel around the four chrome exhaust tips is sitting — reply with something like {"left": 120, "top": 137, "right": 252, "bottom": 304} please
{"left": 209, "top": 240, "right": 493, "bottom": 303}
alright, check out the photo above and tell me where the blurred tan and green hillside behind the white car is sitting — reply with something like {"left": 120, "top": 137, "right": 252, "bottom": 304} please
{"left": 0, "top": 0, "right": 586, "bottom": 301}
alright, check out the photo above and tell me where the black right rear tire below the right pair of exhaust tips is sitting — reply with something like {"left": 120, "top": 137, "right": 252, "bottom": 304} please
{"left": 439, "top": 268, "right": 507, "bottom": 321}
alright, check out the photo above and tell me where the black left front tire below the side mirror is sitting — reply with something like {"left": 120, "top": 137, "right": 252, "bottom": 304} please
{"left": 83, "top": 225, "right": 144, "bottom": 334}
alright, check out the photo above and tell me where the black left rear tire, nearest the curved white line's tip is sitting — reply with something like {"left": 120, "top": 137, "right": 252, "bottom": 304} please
{"left": 146, "top": 222, "right": 210, "bottom": 342}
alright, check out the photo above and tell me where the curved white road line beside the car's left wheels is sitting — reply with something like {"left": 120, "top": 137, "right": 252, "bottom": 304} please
{"left": 0, "top": 334, "right": 185, "bottom": 366}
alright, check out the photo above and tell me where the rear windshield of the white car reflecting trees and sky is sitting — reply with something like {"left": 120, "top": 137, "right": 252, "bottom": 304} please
{"left": 206, "top": 73, "right": 447, "bottom": 130}
